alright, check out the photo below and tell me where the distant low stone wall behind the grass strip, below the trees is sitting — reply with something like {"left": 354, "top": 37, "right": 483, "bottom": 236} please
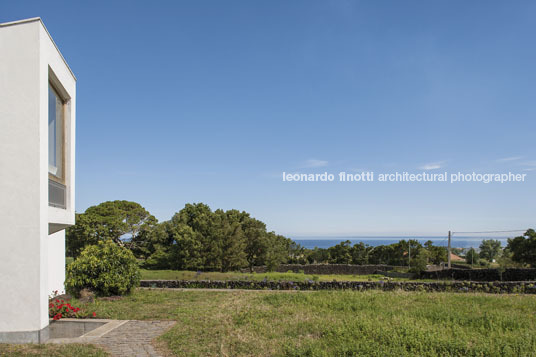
{"left": 241, "top": 264, "right": 396, "bottom": 275}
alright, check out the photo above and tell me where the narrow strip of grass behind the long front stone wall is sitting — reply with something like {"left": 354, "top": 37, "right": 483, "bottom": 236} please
{"left": 141, "top": 269, "right": 414, "bottom": 282}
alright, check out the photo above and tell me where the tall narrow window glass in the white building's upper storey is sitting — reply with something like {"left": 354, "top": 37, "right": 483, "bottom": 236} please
{"left": 48, "top": 84, "right": 63, "bottom": 179}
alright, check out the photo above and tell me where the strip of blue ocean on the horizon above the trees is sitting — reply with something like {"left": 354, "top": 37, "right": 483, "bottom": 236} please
{"left": 290, "top": 236, "right": 508, "bottom": 249}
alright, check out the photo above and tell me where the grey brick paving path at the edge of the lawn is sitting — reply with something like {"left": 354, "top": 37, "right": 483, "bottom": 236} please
{"left": 91, "top": 320, "right": 175, "bottom": 357}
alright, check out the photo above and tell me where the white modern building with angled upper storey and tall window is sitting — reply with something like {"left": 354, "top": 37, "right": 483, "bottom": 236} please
{"left": 0, "top": 18, "right": 76, "bottom": 342}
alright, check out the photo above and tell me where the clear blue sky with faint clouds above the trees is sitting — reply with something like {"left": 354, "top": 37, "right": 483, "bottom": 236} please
{"left": 0, "top": 0, "right": 536, "bottom": 237}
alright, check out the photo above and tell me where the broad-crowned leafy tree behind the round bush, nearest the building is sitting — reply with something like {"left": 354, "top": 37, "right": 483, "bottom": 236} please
{"left": 66, "top": 201, "right": 158, "bottom": 257}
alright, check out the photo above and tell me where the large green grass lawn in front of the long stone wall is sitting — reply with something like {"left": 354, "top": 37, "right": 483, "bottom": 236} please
{"left": 68, "top": 290, "right": 536, "bottom": 356}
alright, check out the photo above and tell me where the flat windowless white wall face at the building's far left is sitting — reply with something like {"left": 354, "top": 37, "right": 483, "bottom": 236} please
{"left": 0, "top": 22, "right": 44, "bottom": 331}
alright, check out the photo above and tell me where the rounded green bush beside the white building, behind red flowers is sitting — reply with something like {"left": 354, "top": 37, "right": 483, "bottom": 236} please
{"left": 65, "top": 240, "right": 140, "bottom": 296}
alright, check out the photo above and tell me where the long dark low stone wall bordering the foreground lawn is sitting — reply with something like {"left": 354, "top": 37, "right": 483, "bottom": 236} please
{"left": 141, "top": 280, "right": 536, "bottom": 294}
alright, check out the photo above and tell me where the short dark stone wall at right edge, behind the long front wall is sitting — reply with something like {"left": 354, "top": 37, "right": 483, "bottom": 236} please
{"left": 420, "top": 269, "right": 536, "bottom": 281}
